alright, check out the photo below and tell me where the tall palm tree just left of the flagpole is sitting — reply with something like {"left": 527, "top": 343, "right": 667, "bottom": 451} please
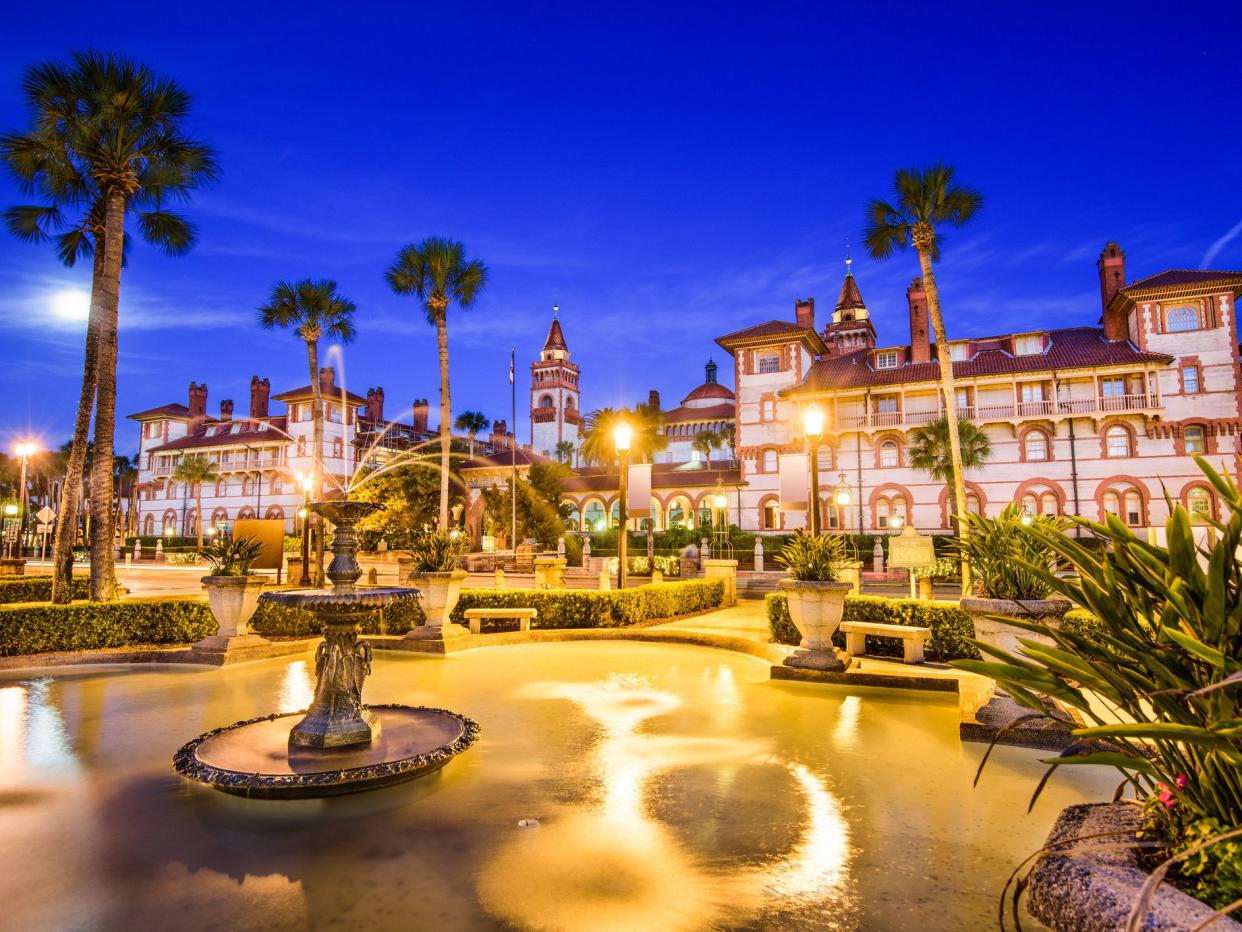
{"left": 385, "top": 236, "right": 487, "bottom": 532}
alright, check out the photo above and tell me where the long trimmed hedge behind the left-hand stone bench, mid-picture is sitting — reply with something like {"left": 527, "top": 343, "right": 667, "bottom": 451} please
{"left": 450, "top": 579, "right": 724, "bottom": 628}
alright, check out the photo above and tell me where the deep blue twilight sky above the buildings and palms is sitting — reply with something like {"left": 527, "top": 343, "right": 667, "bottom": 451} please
{"left": 0, "top": 0, "right": 1242, "bottom": 449}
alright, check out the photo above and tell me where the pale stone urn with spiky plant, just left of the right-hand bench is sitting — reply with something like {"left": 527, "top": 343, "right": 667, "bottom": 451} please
{"left": 775, "top": 533, "right": 851, "bottom": 671}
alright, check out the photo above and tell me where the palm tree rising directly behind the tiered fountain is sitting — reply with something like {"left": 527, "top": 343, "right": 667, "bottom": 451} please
{"left": 257, "top": 278, "right": 358, "bottom": 573}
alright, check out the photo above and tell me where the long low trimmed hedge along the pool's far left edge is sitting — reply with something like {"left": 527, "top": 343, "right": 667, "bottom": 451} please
{"left": 0, "top": 599, "right": 216, "bottom": 657}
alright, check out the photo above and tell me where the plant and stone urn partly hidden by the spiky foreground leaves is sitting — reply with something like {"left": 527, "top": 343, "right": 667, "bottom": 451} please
{"left": 954, "top": 505, "right": 1073, "bottom": 654}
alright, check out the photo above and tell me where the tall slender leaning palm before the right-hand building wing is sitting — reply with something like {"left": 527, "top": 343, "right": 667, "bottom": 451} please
{"left": 863, "top": 163, "right": 984, "bottom": 593}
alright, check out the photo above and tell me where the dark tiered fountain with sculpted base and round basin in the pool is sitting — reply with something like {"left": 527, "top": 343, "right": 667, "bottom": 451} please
{"left": 173, "top": 501, "right": 478, "bottom": 799}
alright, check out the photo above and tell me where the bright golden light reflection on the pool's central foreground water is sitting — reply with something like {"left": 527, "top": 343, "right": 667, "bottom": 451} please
{"left": 479, "top": 671, "right": 850, "bottom": 930}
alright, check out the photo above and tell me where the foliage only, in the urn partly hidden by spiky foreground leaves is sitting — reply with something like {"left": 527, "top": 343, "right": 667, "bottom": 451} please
{"left": 953, "top": 505, "right": 1068, "bottom": 601}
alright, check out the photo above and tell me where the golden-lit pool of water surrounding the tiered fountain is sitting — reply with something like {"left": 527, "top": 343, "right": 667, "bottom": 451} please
{"left": 0, "top": 641, "right": 1115, "bottom": 932}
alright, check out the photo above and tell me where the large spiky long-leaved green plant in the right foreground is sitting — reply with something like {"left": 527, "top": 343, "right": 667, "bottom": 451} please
{"left": 954, "top": 457, "right": 1242, "bottom": 903}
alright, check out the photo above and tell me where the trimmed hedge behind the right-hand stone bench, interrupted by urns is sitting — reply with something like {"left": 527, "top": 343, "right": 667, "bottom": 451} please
{"left": 766, "top": 593, "right": 1095, "bottom": 661}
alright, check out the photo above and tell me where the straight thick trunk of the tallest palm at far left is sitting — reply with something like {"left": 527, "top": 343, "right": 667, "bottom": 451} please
{"left": 91, "top": 189, "right": 125, "bottom": 601}
